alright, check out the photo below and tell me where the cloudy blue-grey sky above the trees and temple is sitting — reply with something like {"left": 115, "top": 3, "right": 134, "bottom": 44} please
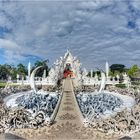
{"left": 0, "top": 0, "right": 140, "bottom": 69}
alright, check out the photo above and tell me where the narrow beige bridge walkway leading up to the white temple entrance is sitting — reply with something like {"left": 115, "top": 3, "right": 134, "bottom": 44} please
{"left": 55, "top": 78, "right": 82, "bottom": 126}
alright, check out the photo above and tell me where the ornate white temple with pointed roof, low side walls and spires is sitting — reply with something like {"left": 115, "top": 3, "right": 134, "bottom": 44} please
{"left": 17, "top": 50, "right": 130, "bottom": 88}
